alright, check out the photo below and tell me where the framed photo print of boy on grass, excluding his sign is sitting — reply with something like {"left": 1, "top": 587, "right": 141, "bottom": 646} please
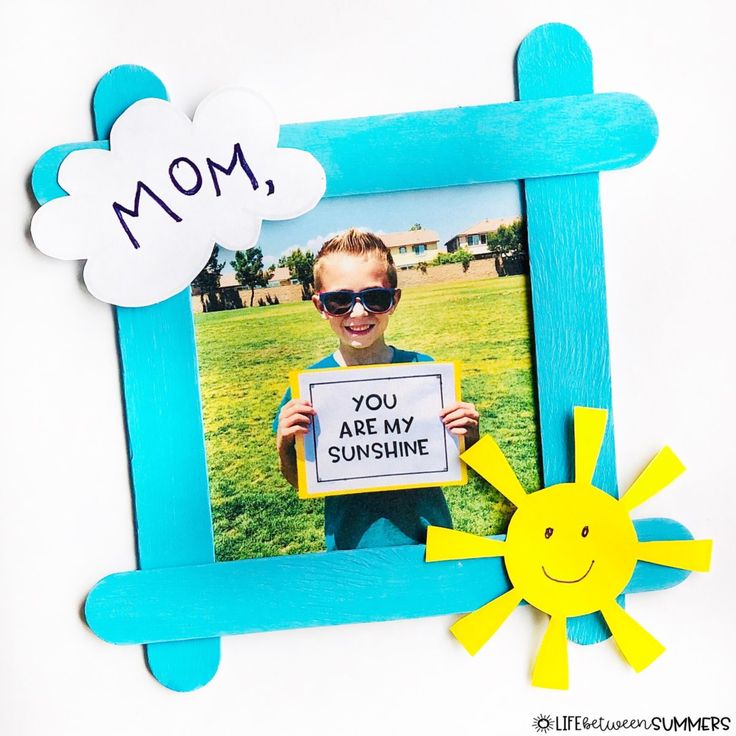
{"left": 191, "top": 182, "right": 539, "bottom": 561}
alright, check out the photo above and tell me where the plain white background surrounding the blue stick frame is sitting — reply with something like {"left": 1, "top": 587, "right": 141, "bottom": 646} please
{"left": 0, "top": 0, "right": 736, "bottom": 736}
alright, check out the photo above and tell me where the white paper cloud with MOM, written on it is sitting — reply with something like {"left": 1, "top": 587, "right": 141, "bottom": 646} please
{"left": 31, "top": 88, "right": 326, "bottom": 307}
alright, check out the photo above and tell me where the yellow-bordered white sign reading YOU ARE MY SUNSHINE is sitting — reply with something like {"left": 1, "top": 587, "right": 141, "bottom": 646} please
{"left": 292, "top": 363, "right": 466, "bottom": 498}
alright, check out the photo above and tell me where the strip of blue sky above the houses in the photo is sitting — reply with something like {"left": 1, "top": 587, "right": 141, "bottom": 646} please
{"left": 220, "top": 182, "right": 521, "bottom": 273}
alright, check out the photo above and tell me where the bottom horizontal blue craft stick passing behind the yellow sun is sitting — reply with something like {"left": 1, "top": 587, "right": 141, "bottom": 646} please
{"left": 85, "top": 519, "right": 692, "bottom": 644}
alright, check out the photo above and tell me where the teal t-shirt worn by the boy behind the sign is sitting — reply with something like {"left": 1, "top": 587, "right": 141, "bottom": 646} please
{"left": 273, "top": 348, "right": 452, "bottom": 551}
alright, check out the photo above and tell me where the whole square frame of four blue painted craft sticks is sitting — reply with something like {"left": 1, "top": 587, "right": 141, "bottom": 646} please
{"left": 32, "top": 24, "right": 691, "bottom": 691}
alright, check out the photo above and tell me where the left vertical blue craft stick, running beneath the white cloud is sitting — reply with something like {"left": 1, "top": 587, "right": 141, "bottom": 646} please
{"left": 92, "top": 66, "right": 220, "bottom": 691}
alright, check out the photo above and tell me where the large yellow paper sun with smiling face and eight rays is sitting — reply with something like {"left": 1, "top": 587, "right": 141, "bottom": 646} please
{"left": 426, "top": 407, "right": 712, "bottom": 690}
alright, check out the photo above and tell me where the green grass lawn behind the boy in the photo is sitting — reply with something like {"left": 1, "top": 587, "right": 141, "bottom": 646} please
{"left": 195, "top": 276, "right": 539, "bottom": 560}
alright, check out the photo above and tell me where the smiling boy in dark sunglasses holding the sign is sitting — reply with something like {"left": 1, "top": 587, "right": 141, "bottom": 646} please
{"left": 275, "top": 229, "right": 478, "bottom": 550}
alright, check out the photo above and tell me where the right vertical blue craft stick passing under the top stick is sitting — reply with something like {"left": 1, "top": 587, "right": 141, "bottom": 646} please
{"left": 517, "top": 24, "right": 640, "bottom": 644}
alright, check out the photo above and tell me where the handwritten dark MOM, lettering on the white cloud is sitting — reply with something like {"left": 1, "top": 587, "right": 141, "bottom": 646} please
{"left": 112, "top": 143, "right": 275, "bottom": 249}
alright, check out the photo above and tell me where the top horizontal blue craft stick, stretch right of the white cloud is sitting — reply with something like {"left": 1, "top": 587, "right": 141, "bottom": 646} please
{"left": 279, "top": 93, "right": 657, "bottom": 197}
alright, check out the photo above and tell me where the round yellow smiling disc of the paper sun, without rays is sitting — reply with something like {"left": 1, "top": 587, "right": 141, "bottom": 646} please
{"left": 505, "top": 483, "right": 637, "bottom": 616}
